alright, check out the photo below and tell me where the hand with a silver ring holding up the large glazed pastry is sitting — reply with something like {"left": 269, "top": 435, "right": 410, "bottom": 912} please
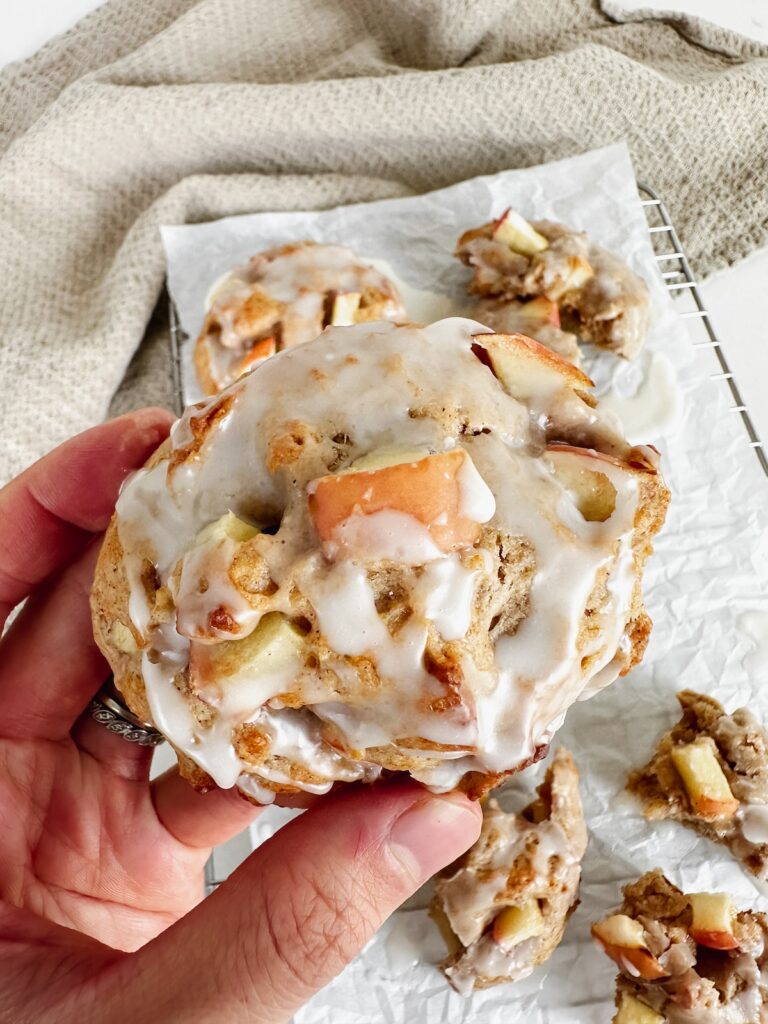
{"left": 0, "top": 410, "right": 480, "bottom": 1024}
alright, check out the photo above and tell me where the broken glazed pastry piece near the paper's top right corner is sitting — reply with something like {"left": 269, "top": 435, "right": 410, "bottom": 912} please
{"left": 456, "top": 209, "right": 648, "bottom": 359}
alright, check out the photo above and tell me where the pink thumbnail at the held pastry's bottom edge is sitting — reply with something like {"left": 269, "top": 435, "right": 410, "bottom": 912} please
{"left": 389, "top": 795, "right": 482, "bottom": 882}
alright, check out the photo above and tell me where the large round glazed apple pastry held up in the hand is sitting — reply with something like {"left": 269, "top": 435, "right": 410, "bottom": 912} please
{"left": 92, "top": 318, "right": 669, "bottom": 801}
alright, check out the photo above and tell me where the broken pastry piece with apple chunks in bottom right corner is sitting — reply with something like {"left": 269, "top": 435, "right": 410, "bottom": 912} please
{"left": 592, "top": 869, "right": 768, "bottom": 1024}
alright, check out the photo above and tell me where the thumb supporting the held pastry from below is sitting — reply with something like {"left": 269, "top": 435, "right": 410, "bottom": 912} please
{"left": 126, "top": 784, "right": 481, "bottom": 1024}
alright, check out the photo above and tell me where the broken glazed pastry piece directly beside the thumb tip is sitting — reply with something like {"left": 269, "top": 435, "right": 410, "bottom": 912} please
{"left": 430, "top": 749, "right": 587, "bottom": 995}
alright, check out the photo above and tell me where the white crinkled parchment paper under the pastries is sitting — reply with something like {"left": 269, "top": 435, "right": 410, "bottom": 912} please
{"left": 163, "top": 145, "right": 768, "bottom": 1024}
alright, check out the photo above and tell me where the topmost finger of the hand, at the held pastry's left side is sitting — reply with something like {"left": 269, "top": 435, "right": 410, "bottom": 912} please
{"left": 0, "top": 409, "right": 173, "bottom": 627}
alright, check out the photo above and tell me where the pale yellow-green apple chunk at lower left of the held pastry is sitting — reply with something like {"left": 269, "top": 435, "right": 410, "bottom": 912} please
{"left": 189, "top": 611, "right": 305, "bottom": 713}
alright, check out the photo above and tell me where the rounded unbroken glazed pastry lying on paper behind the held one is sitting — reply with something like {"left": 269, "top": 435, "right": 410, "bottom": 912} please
{"left": 194, "top": 242, "right": 407, "bottom": 394}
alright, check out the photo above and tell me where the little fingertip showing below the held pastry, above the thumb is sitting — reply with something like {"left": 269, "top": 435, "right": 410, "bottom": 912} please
{"left": 152, "top": 768, "right": 263, "bottom": 847}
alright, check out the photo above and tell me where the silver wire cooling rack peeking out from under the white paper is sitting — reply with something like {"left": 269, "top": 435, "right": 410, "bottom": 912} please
{"left": 169, "top": 181, "right": 768, "bottom": 894}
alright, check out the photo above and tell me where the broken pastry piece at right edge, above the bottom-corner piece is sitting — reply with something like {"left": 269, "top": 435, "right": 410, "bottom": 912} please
{"left": 628, "top": 690, "right": 768, "bottom": 879}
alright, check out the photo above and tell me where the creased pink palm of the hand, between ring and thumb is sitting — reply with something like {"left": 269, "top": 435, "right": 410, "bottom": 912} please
{"left": 0, "top": 739, "right": 207, "bottom": 949}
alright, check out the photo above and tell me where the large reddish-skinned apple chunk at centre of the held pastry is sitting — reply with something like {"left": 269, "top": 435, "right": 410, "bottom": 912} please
{"left": 307, "top": 449, "right": 493, "bottom": 551}
